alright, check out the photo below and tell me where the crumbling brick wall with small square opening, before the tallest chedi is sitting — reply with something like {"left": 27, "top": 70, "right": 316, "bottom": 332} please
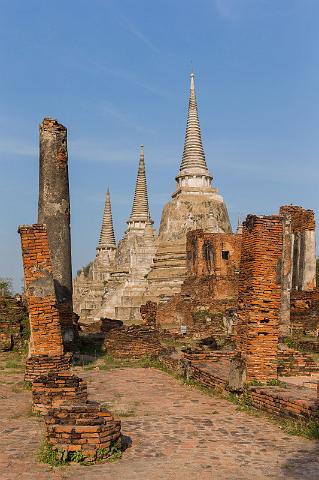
{"left": 157, "top": 230, "right": 241, "bottom": 333}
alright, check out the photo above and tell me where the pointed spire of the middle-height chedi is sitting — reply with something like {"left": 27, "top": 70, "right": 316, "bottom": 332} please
{"left": 127, "top": 145, "right": 153, "bottom": 225}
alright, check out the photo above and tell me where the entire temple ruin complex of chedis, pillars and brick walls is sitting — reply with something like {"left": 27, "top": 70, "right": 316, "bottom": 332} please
{"left": 5, "top": 74, "right": 319, "bottom": 468}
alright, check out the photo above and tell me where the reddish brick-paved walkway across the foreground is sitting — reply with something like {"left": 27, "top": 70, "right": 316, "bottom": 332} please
{"left": 0, "top": 369, "right": 319, "bottom": 480}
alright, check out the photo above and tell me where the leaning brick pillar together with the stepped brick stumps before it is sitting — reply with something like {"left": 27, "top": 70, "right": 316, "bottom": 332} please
{"left": 19, "top": 224, "right": 121, "bottom": 460}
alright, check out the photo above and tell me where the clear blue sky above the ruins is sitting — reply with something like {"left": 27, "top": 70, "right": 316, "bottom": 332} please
{"left": 0, "top": 0, "right": 319, "bottom": 289}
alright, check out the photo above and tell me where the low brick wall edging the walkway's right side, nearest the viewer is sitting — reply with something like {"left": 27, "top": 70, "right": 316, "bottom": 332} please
{"left": 248, "top": 387, "right": 319, "bottom": 419}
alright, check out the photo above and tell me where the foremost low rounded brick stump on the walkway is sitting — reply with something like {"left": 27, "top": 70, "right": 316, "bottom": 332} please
{"left": 45, "top": 402, "right": 121, "bottom": 460}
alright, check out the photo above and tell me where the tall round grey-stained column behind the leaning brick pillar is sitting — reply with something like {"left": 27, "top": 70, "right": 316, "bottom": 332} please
{"left": 38, "top": 118, "right": 74, "bottom": 348}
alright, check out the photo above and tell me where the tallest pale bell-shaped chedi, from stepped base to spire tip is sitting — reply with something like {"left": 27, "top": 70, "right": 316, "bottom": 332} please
{"left": 146, "top": 73, "right": 231, "bottom": 300}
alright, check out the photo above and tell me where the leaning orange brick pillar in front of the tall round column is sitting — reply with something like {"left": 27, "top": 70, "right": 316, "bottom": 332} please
{"left": 18, "top": 225, "right": 70, "bottom": 380}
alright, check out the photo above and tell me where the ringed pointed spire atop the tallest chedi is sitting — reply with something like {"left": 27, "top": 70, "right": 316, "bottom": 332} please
{"left": 180, "top": 72, "right": 208, "bottom": 174}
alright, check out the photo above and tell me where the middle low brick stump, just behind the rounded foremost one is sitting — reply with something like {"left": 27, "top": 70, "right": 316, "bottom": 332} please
{"left": 32, "top": 372, "right": 88, "bottom": 414}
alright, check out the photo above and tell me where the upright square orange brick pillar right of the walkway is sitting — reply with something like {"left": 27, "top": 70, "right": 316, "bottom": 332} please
{"left": 236, "top": 215, "right": 283, "bottom": 382}
